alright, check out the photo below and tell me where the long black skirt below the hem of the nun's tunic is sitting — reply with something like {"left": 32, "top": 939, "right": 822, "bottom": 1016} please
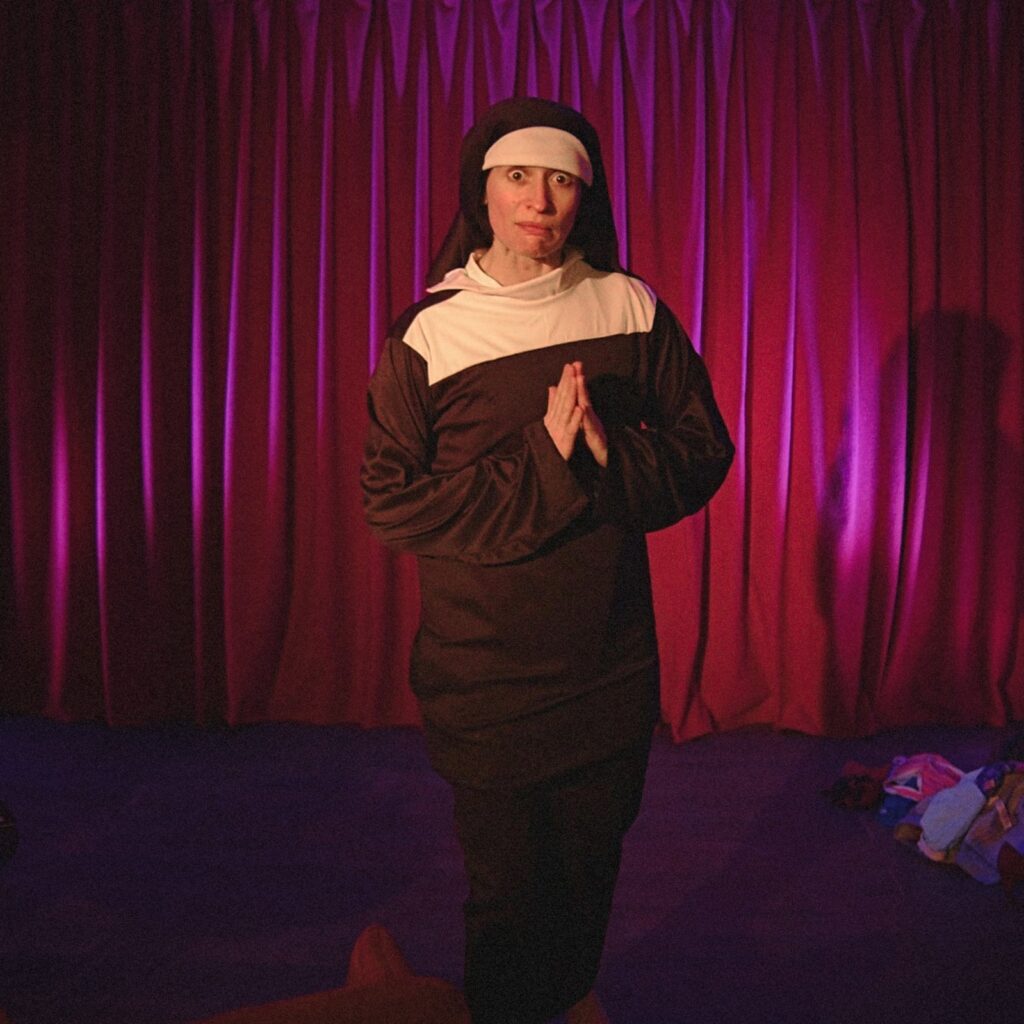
{"left": 455, "top": 742, "right": 649, "bottom": 1024}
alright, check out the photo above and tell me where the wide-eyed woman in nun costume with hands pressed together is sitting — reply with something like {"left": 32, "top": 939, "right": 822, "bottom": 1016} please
{"left": 362, "top": 99, "right": 733, "bottom": 1024}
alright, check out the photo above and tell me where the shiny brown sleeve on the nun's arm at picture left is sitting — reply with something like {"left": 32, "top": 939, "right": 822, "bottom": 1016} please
{"left": 361, "top": 338, "right": 589, "bottom": 565}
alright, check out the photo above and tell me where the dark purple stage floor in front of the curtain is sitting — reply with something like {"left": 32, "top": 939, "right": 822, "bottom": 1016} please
{"left": 0, "top": 719, "right": 1024, "bottom": 1024}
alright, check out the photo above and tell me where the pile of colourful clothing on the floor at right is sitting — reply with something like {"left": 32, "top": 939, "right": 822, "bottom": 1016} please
{"left": 825, "top": 737, "right": 1024, "bottom": 905}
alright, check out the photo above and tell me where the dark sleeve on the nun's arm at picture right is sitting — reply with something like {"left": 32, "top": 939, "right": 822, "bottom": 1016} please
{"left": 596, "top": 302, "right": 734, "bottom": 531}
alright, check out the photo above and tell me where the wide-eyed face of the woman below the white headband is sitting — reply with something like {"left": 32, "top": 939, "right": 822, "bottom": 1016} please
{"left": 484, "top": 167, "right": 583, "bottom": 261}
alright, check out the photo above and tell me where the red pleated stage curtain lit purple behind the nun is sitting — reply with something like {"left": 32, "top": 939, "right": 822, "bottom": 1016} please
{"left": 0, "top": 0, "right": 1024, "bottom": 738}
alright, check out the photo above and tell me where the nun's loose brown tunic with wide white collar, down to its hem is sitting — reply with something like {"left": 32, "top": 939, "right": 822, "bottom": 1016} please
{"left": 362, "top": 254, "right": 733, "bottom": 787}
